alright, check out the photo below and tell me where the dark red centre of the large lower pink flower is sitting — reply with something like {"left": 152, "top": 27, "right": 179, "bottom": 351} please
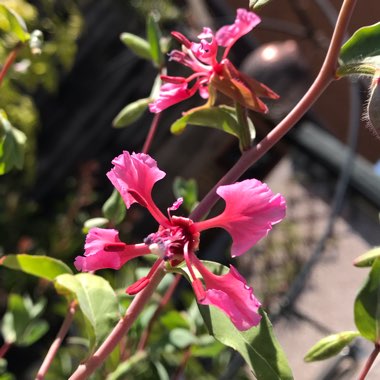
{"left": 144, "top": 216, "right": 199, "bottom": 265}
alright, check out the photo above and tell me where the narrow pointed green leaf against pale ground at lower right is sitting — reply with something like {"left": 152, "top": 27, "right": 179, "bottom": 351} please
{"left": 304, "top": 331, "right": 360, "bottom": 362}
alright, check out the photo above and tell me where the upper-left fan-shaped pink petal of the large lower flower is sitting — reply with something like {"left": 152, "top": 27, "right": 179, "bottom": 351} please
{"left": 107, "top": 151, "right": 167, "bottom": 225}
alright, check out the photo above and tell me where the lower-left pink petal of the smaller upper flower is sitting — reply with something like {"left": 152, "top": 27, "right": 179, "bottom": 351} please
{"left": 149, "top": 78, "right": 196, "bottom": 113}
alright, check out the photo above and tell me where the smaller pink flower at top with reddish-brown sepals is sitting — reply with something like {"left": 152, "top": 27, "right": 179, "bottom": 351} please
{"left": 149, "top": 9, "right": 278, "bottom": 113}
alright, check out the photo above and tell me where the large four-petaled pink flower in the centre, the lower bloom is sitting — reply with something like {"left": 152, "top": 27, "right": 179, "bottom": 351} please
{"left": 75, "top": 151, "right": 286, "bottom": 330}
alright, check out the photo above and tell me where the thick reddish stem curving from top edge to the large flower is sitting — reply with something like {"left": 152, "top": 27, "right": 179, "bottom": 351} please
{"left": 190, "top": 0, "right": 357, "bottom": 221}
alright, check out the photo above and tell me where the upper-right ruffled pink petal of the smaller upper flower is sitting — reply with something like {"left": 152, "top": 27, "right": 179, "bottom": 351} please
{"left": 215, "top": 8, "right": 261, "bottom": 48}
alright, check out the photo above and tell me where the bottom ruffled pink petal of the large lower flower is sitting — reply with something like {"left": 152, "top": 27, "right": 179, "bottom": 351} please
{"left": 193, "top": 259, "right": 261, "bottom": 331}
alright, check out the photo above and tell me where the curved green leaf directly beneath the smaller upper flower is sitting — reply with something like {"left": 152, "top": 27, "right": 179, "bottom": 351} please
{"left": 170, "top": 106, "right": 239, "bottom": 137}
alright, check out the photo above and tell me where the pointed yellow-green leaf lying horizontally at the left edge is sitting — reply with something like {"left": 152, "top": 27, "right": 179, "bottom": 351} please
{"left": 0, "top": 254, "right": 72, "bottom": 281}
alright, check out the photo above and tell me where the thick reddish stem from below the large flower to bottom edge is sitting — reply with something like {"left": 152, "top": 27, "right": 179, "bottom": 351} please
{"left": 69, "top": 266, "right": 165, "bottom": 380}
